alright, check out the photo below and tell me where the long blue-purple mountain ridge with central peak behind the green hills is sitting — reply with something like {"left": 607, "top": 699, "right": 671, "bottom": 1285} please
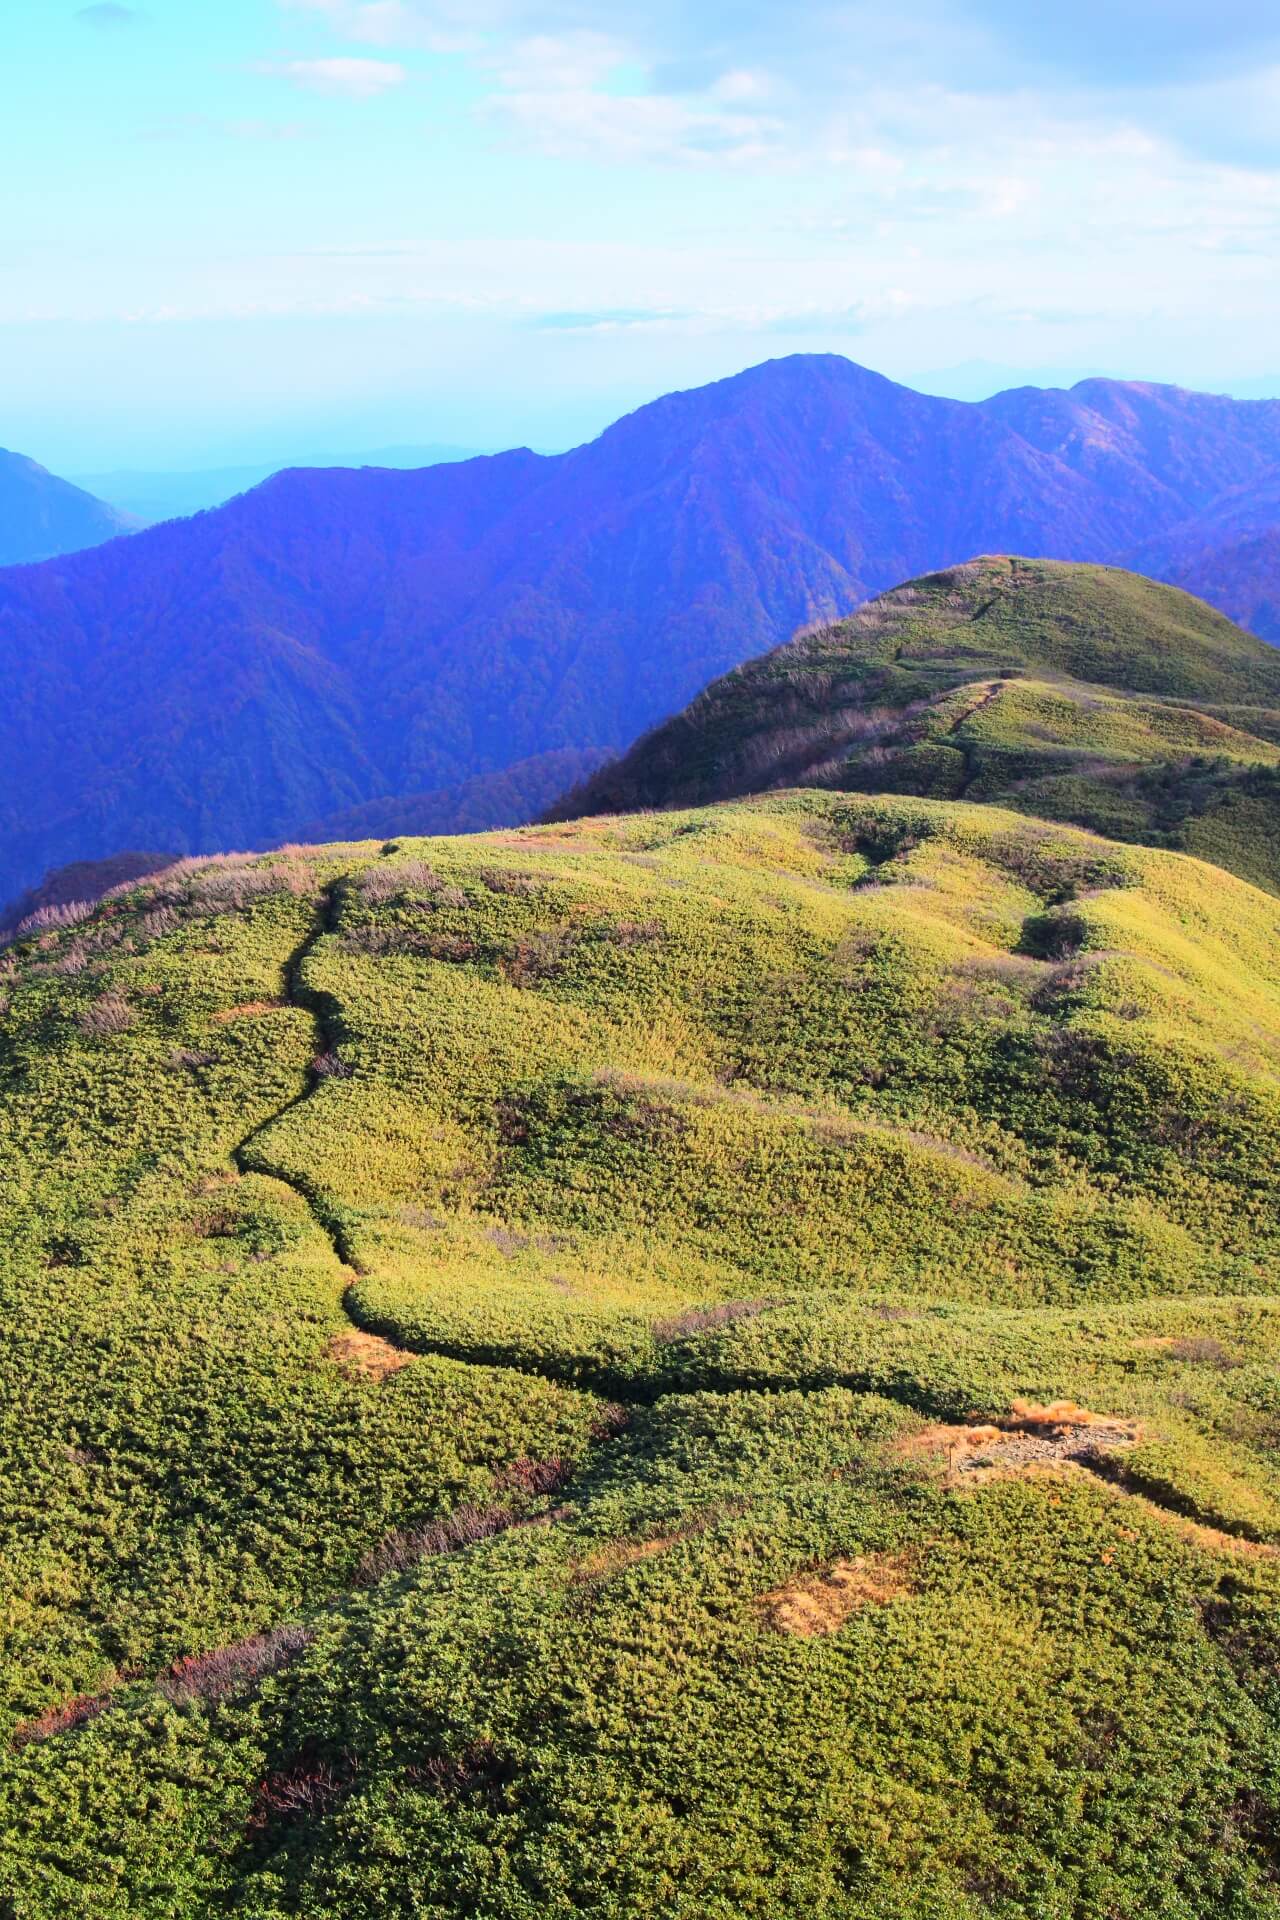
{"left": 0, "top": 355, "right": 1280, "bottom": 895}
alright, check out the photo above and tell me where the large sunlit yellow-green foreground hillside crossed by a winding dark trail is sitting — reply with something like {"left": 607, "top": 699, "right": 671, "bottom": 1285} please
{"left": 0, "top": 791, "right": 1280, "bottom": 1920}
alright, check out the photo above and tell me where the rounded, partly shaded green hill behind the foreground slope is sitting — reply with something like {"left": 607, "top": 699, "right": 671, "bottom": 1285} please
{"left": 555, "top": 557, "right": 1280, "bottom": 891}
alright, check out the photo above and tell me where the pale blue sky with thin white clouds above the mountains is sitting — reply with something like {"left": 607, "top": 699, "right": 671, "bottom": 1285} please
{"left": 0, "top": 0, "right": 1280, "bottom": 472}
